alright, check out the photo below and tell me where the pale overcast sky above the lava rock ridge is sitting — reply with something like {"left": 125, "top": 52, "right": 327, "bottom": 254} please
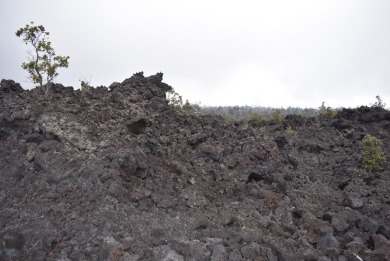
{"left": 0, "top": 0, "right": 390, "bottom": 107}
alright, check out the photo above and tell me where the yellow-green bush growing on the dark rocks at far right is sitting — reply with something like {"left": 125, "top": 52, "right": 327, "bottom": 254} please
{"left": 362, "top": 135, "right": 386, "bottom": 171}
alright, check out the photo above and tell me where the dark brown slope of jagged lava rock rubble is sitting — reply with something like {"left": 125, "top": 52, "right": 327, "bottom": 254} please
{"left": 0, "top": 73, "right": 390, "bottom": 261}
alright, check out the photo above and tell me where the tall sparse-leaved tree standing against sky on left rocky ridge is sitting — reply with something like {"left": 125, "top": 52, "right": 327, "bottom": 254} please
{"left": 16, "top": 22, "right": 69, "bottom": 93}
